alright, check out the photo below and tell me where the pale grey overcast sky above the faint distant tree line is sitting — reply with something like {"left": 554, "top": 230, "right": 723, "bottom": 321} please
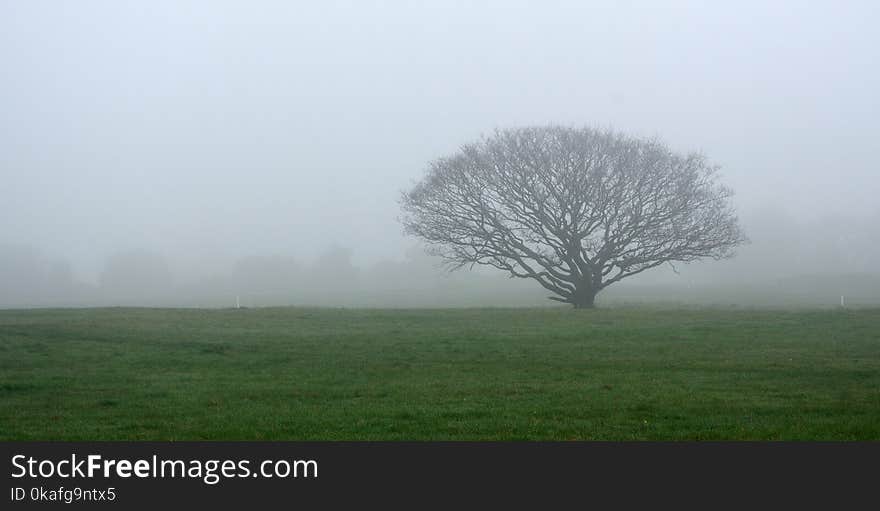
{"left": 0, "top": 0, "right": 880, "bottom": 284}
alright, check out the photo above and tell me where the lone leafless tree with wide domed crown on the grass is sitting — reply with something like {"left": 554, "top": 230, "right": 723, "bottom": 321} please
{"left": 401, "top": 126, "right": 745, "bottom": 308}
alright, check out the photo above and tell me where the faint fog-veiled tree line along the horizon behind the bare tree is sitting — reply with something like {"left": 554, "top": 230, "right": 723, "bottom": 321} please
{"left": 0, "top": 207, "right": 880, "bottom": 307}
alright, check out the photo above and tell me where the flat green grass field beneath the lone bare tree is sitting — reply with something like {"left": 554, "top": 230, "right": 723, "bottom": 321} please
{"left": 0, "top": 308, "right": 880, "bottom": 440}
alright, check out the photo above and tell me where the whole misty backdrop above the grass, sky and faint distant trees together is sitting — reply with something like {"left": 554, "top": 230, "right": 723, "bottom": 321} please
{"left": 0, "top": 1, "right": 880, "bottom": 308}
